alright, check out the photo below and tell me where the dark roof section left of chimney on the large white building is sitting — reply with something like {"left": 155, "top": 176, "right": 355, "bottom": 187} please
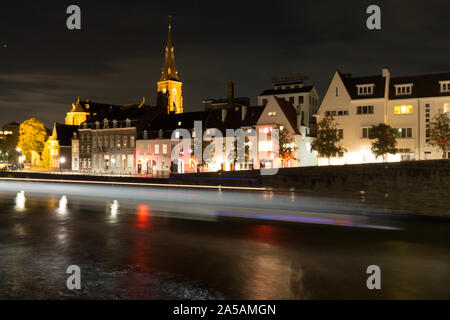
{"left": 337, "top": 71, "right": 386, "bottom": 100}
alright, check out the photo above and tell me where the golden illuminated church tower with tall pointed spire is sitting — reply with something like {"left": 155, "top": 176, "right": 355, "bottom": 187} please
{"left": 158, "top": 16, "right": 183, "bottom": 113}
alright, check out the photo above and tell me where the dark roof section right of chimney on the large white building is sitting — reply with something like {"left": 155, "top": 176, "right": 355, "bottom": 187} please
{"left": 389, "top": 72, "right": 450, "bottom": 99}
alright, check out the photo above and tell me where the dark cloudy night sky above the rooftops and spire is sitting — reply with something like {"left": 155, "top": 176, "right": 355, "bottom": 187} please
{"left": 0, "top": 0, "right": 450, "bottom": 126}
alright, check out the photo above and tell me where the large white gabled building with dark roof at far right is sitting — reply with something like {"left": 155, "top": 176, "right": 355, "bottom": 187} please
{"left": 317, "top": 69, "right": 450, "bottom": 165}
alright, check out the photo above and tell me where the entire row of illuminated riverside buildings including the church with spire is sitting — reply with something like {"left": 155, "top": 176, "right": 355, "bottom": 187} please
{"left": 46, "top": 18, "right": 450, "bottom": 176}
